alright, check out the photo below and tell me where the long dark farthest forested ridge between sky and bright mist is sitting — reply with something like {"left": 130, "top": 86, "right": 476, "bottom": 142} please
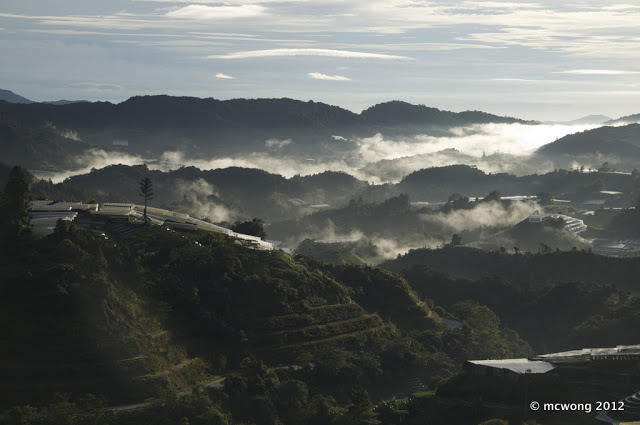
{"left": 0, "top": 95, "right": 524, "bottom": 153}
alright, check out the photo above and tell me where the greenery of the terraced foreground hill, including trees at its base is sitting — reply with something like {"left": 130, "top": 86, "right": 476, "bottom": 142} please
{"left": 0, "top": 198, "right": 530, "bottom": 424}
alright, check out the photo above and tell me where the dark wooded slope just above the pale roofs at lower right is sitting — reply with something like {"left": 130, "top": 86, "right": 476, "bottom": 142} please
{"left": 402, "top": 264, "right": 640, "bottom": 353}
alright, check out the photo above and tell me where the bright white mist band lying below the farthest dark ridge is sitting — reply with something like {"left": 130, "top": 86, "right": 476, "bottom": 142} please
{"left": 36, "top": 124, "right": 595, "bottom": 184}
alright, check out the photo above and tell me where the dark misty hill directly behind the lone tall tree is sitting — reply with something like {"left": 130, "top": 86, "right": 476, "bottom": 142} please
{"left": 33, "top": 165, "right": 368, "bottom": 221}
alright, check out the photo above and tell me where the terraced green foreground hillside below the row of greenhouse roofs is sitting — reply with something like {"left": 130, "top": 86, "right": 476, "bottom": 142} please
{"left": 0, "top": 215, "right": 456, "bottom": 407}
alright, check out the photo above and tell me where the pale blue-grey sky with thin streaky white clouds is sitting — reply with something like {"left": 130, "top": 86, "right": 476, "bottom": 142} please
{"left": 0, "top": 0, "right": 640, "bottom": 121}
